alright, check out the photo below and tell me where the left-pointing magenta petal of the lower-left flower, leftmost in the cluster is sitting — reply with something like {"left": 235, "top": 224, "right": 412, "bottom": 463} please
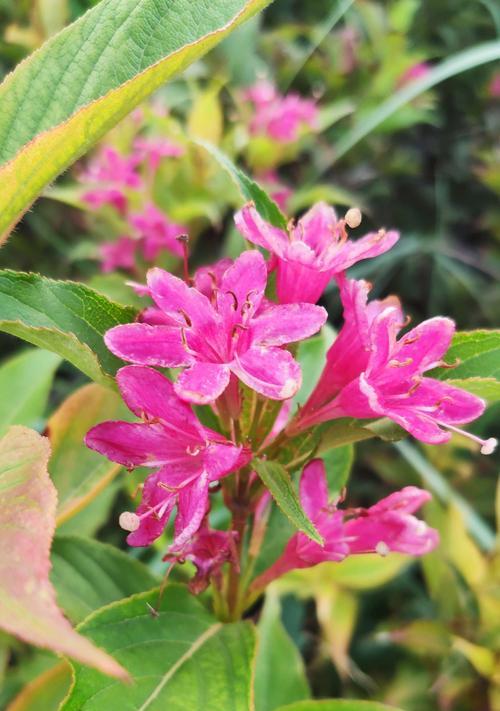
{"left": 85, "top": 421, "right": 172, "bottom": 469}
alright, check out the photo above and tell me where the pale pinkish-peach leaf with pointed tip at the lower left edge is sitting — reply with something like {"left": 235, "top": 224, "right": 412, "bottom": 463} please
{"left": 0, "top": 426, "right": 127, "bottom": 679}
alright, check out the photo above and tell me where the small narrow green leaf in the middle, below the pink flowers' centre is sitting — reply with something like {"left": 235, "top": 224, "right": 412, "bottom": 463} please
{"left": 252, "top": 459, "right": 323, "bottom": 545}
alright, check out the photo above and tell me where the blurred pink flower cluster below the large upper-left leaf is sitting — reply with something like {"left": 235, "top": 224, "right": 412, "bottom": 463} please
{"left": 80, "top": 138, "right": 186, "bottom": 272}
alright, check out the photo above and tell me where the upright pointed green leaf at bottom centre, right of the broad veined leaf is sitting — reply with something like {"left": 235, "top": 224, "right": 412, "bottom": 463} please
{"left": 255, "top": 592, "right": 311, "bottom": 711}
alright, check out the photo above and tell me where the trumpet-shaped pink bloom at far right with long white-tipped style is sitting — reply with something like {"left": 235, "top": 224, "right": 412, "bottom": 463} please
{"left": 290, "top": 278, "right": 495, "bottom": 454}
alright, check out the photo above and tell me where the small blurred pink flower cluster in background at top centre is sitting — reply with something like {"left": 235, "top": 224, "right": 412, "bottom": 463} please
{"left": 244, "top": 80, "right": 318, "bottom": 143}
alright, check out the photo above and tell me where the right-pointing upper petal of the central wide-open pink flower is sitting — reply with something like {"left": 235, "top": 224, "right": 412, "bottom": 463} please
{"left": 252, "top": 304, "right": 328, "bottom": 346}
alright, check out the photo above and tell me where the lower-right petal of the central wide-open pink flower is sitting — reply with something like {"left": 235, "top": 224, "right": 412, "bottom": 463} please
{"left": 231, "top": 346, "right": 302, "bottom": 400}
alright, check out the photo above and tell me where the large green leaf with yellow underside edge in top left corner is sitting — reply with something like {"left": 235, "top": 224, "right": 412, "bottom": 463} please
{"left": 0, "top": 0, "right": 270, "bottom": 241}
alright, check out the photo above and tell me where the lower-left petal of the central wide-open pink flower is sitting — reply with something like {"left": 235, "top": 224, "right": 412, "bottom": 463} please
{"left": 174, "top": 362, "right": 230, "bottom": 405}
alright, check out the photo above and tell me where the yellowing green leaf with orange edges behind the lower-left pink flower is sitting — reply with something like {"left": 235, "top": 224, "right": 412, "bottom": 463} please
{"left": 47, "top": 383, "right": 131, "bottom": 526}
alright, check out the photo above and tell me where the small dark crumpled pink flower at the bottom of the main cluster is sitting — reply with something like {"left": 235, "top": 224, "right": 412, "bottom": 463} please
{"left": 163, "top": 524, "right": 238, "bottom": 595}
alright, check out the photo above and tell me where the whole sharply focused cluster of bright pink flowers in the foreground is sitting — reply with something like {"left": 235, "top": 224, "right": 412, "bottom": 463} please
{"left": 86, "top": 197, "right": 495, "bottom": 592}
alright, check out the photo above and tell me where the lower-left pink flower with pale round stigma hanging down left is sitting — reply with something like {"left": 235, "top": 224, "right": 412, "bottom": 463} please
{"left": 85, "top": 366, "right": 250, "bottom": 550}
